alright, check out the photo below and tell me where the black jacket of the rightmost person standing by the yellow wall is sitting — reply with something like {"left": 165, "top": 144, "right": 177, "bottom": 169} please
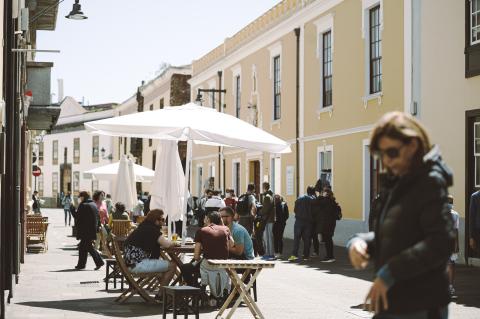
{"left": 312, "top": 197, "right": 341, "bottom": 235}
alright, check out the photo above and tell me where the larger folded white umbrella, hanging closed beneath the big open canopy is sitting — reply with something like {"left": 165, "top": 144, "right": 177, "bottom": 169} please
{"left": 150, "top": 140, "right": 185, "bottom": 237}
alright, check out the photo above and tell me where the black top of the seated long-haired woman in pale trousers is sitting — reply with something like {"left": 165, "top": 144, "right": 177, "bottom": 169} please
{"left": 124, "top": 220, "right": 162, "bottom": 258}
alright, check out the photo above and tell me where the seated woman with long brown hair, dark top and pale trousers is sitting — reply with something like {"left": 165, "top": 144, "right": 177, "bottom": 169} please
{"left": 124, "top": 209, "right": 175, "bottom": 292}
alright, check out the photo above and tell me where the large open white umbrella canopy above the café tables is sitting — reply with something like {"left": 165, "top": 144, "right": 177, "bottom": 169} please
{"left": 85, "top": 103, "right": 291, "bottom": 153}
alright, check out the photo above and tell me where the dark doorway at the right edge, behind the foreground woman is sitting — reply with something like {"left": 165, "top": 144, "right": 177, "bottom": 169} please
{"left": 465, "top": 109, "right": 480, "bottom": 262}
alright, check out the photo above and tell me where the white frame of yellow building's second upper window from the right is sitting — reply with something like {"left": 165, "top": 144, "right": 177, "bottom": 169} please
{"left": 313, "top": 13, "right": 335, "bottom": 114}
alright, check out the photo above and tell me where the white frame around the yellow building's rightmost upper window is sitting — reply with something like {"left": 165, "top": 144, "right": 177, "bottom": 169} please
{"left": 362, "top": 0, "right": 384, "bottom": 102}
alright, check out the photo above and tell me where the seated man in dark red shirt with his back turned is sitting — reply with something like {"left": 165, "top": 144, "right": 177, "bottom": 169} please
{"left": 182, "top": 211, "right": 233, "bottom": 304}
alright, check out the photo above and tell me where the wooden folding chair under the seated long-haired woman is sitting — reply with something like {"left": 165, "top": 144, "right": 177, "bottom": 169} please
{"left": 112, "top": 234, "right": 163, "bottom": 303}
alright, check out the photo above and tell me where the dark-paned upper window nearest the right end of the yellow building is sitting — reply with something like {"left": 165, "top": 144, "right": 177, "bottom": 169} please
{"left": 369, "top": 5, "right": 382, "bottom": 94}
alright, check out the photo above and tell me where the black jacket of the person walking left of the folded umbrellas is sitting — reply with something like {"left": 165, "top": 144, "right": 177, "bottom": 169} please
{"left": 73, "top": 199, "right": 98, "bottom": 240}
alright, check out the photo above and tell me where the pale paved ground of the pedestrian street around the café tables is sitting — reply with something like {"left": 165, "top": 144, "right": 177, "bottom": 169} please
{"left": 6, "top": 209, "right": 480, "bottom": 319}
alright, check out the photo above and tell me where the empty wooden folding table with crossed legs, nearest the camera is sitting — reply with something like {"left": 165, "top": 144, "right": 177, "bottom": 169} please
{"left": 208, "top": 259, "right": 275, "bottom": 319}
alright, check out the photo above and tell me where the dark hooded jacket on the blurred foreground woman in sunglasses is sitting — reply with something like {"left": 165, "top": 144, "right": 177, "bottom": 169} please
{"left": 357, "top": 147, "right": 454, "bottom": 313}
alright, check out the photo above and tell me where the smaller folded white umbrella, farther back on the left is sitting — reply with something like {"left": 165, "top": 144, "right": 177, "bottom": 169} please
{"left": 113, "top": 155, "right": 137, "bottom": 210}
